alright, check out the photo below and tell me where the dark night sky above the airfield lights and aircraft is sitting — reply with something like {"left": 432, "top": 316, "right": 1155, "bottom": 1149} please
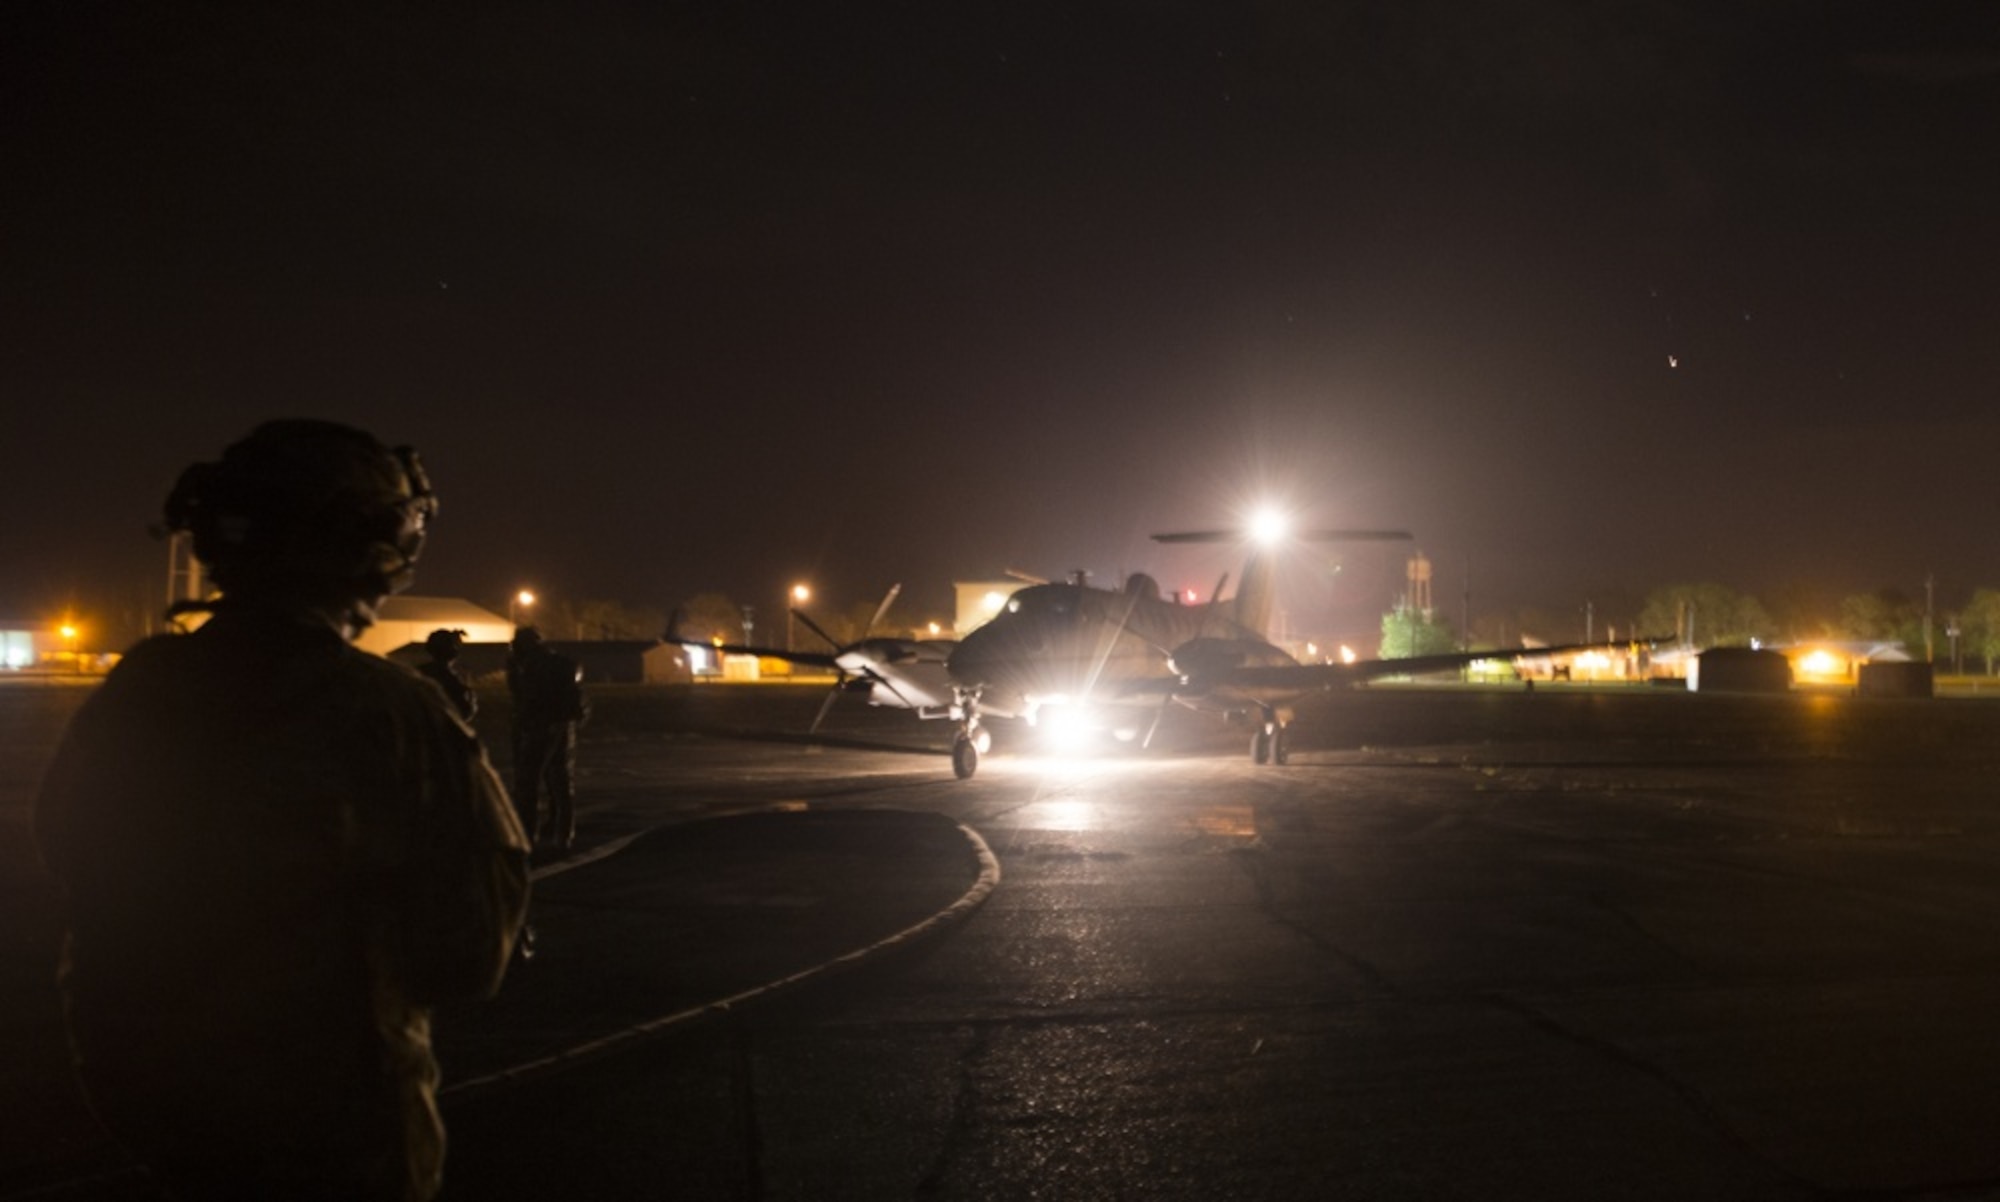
{"left": 0, "top": 0, "right": 2000, "bottom": 648}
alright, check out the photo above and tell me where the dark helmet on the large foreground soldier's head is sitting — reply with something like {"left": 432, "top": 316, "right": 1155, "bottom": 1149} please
{"left": 166, "top": 420, "right": 438, "bottom": 600}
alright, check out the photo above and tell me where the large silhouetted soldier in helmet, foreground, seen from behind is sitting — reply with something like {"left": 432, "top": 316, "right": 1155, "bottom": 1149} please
{"left": 36, "top": 422, "right": 528, "bottom": 1202}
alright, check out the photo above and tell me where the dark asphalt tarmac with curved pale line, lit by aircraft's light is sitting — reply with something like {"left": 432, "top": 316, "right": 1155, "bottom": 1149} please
{"left": 11, "top": 688, "right": 2000, "bottom": 1202}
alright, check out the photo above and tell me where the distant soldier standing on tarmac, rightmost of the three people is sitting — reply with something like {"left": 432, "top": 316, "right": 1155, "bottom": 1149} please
{"left": 506, "top": 626, "right": 590, "bottom": 852}
